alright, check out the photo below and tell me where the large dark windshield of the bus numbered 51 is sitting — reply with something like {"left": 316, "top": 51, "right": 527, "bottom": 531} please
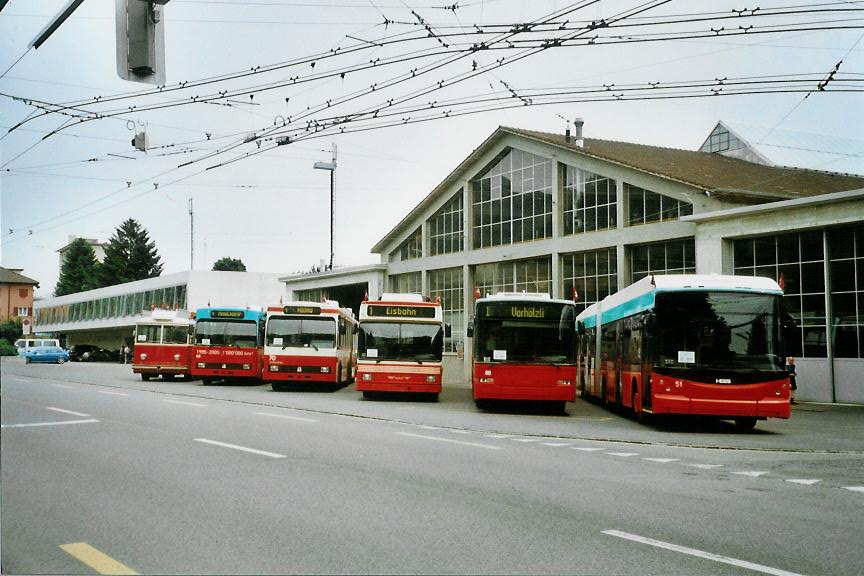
{"left": 655, "top": 292, "right": 783, "bottom": 372}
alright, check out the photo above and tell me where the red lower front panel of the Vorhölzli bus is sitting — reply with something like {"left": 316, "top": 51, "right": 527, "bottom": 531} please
{"left": 471, "top": 362, "right": 576, "bottom": 402}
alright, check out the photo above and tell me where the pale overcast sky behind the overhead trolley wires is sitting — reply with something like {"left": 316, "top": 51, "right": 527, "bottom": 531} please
{"left": 0, "top": 0, "right": 864, "bottom": 297}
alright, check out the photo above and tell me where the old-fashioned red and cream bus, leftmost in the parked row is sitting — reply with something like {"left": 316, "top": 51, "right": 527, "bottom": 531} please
{"left": 132, "top": 309, "right": 192, "bottom": 380}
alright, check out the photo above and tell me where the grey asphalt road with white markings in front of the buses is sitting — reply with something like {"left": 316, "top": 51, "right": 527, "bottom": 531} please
{"left": 0, "top": 358, "right": 864, "bottom": 575}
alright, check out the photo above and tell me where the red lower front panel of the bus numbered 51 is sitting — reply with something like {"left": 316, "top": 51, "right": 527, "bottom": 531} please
{"left": 651, "top": 373, "right": 791, "bottom": 418}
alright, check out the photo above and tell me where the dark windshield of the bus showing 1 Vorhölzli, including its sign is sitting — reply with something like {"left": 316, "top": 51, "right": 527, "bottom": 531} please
{"left": 474, "top": 302, "right": 576, "bottom": 364}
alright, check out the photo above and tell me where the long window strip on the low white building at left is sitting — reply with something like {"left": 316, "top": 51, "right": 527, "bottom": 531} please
{"left": 36, "top": 284, "right": 186, "bottom": 325}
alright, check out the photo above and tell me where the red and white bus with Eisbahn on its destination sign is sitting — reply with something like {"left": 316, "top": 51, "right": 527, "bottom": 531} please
{"left": 356, "top": 293, "right": 445, "bottom": 400}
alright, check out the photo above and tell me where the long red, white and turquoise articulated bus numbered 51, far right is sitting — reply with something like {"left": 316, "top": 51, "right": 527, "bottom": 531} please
{"left": 577, "top": 275, "right": 789, "bottom": 429}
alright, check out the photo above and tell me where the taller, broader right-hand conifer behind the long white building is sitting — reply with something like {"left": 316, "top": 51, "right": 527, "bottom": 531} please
{"left": 99, "top": 218, "right": 162, "bottom": 286}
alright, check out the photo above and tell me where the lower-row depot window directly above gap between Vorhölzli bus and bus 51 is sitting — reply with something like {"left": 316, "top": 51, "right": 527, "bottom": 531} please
{"left": 561, "top": 248, "right": 618, "bottom": 312}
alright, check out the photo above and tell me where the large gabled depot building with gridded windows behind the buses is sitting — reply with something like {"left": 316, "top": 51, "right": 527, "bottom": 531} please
{"left": 280, "top": 122, "right": 864, "bottom": 403}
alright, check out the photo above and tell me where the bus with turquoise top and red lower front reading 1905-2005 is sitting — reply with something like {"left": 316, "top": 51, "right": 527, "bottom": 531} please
{"left": 192, "top": 308, "right": 265, "bottom": 384}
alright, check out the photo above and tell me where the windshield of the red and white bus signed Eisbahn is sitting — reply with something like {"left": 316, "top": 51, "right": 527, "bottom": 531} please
{"left": 358, "top": 322, "right": 444, "bottom": 362}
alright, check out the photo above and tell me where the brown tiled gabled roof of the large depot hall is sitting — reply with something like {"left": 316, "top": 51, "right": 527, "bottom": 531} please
{"left": 372, "top": 126, "right": 864, "bottom": 254}
